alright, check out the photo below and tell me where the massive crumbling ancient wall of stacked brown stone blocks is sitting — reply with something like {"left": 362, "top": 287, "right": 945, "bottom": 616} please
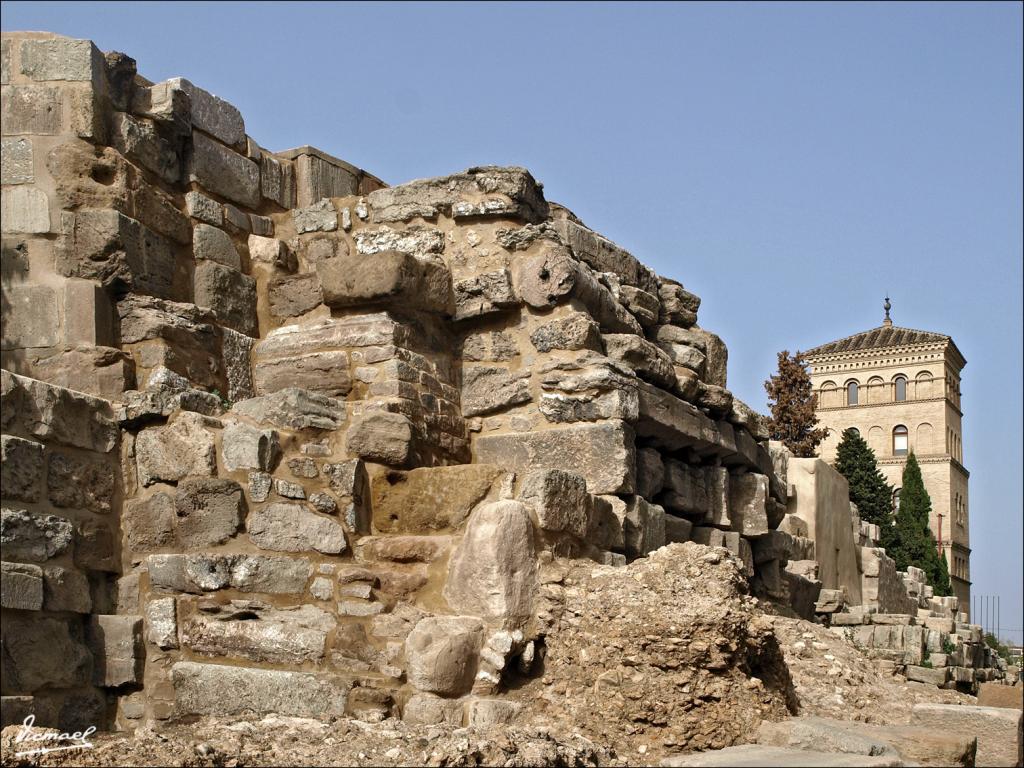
{"left": 2, "top": 33, "right": 1011, "bottom": 765}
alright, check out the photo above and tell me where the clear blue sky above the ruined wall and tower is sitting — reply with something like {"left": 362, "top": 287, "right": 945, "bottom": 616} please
{"left": 2, "top": 2, "right": 1024, "bottom": 641}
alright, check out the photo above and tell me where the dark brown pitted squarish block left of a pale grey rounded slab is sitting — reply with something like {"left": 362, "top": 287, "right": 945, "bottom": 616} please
{"left": 174, "top": 477, "right": 242, "bottom": 548}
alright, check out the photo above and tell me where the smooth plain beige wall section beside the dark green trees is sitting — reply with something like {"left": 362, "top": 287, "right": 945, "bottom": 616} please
{"left": 786, "top": 459, "right": 861, "bottom": 605}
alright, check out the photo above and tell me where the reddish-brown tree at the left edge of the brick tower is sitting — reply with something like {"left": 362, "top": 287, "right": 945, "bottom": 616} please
{"left": 765, "top": 350, "right": 827, "bottom": 459}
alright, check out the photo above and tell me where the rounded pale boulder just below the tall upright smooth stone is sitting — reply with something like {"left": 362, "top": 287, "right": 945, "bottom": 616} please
{"left": 406, "top": 616, "right": 483, "bottom": 696}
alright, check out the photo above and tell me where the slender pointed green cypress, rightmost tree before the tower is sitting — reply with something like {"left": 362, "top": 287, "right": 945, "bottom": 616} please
{"left": 886, "top": 452, "right": 951, "bottom": 595}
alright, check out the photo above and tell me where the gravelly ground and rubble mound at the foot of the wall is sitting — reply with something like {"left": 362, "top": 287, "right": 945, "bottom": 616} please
{"left": 2, "top": 544, "right": 974, "bottom": 766}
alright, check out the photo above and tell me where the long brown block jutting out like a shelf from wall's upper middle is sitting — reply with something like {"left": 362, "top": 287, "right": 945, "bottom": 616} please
{"left": 316, "top": 251, "right": 454, "bottom": 314}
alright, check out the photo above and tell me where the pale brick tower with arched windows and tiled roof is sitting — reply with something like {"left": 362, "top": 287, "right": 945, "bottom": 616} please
{"left": 804, "top": 298, "right": 971, "bottom": 612}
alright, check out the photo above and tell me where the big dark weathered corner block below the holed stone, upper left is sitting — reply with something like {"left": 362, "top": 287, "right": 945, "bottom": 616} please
{"left": 57, "top": 209, "right": 176, "bottom": 298}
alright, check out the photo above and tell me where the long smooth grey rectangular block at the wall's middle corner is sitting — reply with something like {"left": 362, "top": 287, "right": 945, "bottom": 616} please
{"left": 474, "top": 421, "right": 636, "bottom": 494}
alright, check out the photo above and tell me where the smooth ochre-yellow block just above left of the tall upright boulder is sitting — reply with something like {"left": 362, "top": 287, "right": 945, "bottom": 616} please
{"left": 374, "top": 464, "right": 505, "bottom": 534}
